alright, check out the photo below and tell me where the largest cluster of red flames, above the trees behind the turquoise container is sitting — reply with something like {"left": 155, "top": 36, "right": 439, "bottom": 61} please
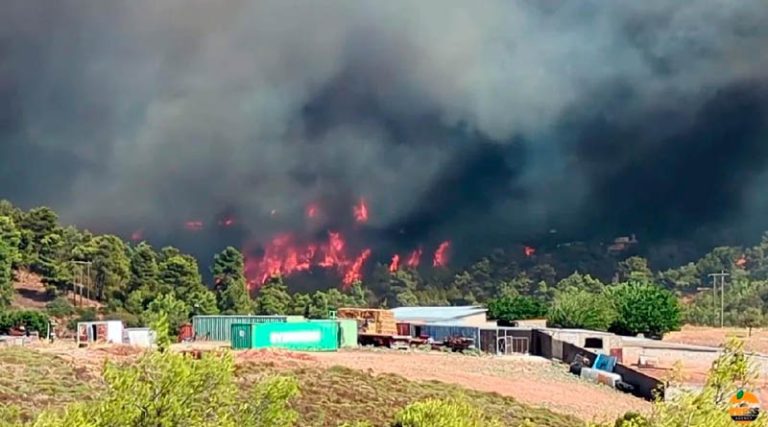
{"left": 245, "top": 232, "right": 371, "bottom": 288}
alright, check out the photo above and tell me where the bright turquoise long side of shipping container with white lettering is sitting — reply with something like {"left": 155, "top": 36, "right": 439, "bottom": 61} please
{"left": 253, "top": 322, "right": 339, "bottom": 351}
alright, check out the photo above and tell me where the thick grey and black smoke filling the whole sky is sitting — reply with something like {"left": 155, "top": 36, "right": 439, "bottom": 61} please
{"left": 0, "top": 0, "right": 768, "bottom": 264}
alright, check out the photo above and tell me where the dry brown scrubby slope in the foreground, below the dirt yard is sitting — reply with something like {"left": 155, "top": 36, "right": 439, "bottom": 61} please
{"left": 0, "top": 346, "right": 605, "bottom": 427}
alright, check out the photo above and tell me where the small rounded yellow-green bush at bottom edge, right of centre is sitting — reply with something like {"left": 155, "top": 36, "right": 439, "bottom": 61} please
{"left": 392, "top": 399, "right": 501, "bottom": 427}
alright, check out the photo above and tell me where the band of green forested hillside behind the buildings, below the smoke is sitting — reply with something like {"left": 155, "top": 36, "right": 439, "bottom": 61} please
{"left": 0, "top": 201, "right": 768, "bottom": 332}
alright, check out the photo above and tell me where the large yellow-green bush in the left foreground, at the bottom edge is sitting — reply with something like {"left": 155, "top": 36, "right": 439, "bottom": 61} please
{"left": 34, "top": 351, "right": 298, "bottom": 427}
